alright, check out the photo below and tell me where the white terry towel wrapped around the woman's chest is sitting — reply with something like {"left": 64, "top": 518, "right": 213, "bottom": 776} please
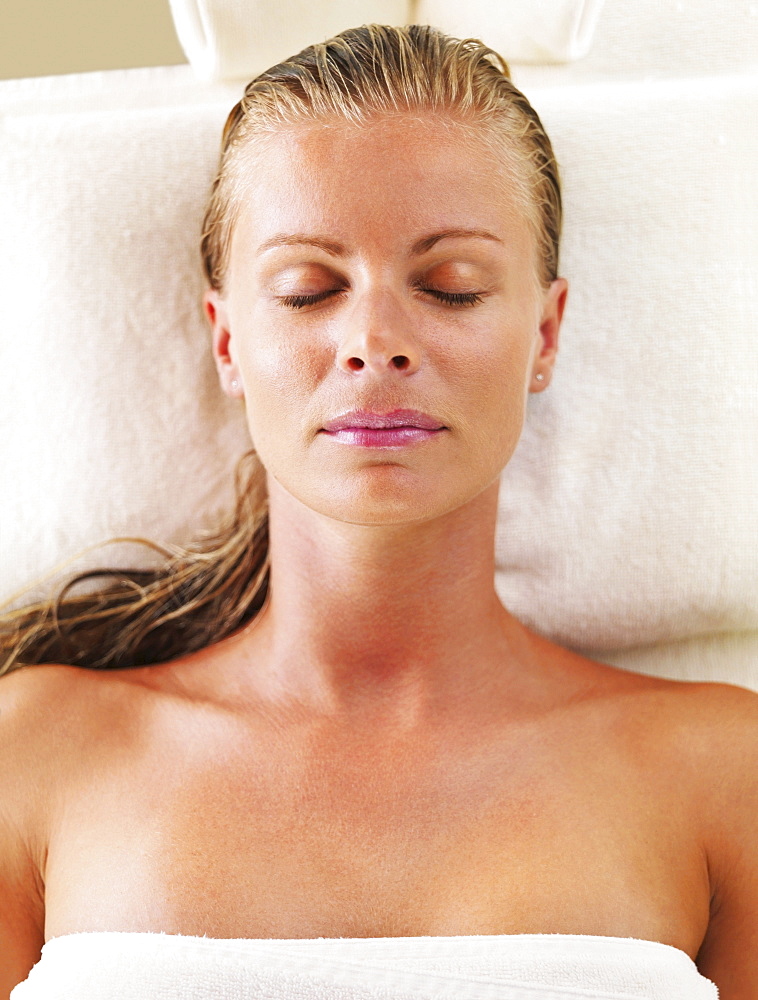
{"left": 10, "top": 931, "right": 718, "bottom": 1000}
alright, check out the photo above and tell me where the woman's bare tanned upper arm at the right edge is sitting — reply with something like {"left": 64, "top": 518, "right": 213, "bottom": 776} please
{"left": 696, "top": 684, "right": 758, "bottom": 1000}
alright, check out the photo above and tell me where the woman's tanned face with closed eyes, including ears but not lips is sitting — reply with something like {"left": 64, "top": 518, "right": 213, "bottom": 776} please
{"left": 206, "top": 115, "right": 566, "bottom": 524}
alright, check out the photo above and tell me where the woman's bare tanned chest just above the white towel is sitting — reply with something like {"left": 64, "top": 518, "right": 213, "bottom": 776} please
{"left": 41, "top": 708, "right": 709, "bottom": 956}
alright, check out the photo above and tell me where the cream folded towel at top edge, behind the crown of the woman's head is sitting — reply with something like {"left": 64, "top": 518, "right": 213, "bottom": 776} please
{"left": 170, "top": 0, "right": 604, "bottom": 80}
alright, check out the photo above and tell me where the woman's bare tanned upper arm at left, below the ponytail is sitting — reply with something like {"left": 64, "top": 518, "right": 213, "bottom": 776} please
{"left": 0, "top": 668, "right": 49, "bottom": 1000}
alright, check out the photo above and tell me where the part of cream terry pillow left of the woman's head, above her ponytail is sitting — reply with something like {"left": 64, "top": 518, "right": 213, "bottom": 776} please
{"left": 0, "top": 95, "right": 249, "bottom": 604}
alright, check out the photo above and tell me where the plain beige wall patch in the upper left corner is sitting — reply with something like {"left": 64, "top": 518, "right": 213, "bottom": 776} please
{"left": 0, "top": 0, "right": 187, "bottom": 80}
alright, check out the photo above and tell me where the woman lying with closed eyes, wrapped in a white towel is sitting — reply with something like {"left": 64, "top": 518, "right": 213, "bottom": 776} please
{"left": 0, "top": 19, "right": 758, "bottom": 1000}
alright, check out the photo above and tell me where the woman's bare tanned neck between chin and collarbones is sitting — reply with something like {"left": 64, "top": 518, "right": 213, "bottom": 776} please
{"left": 220, "top": 478, "right": 533, "bottom": 726}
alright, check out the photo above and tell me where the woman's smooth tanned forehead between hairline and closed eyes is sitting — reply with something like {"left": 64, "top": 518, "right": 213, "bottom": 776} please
{"left": 233, "top": 113, "right": 531, "bottom": 262}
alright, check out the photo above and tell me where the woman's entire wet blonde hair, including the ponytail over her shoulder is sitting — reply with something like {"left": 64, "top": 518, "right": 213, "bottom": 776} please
{"left": 0, "top": 24, "right": 562, "bottom": 674}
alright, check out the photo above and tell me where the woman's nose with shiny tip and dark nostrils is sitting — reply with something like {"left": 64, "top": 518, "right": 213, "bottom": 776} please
{"left": 337, "top": 288, "right": 420, "bottom": 375}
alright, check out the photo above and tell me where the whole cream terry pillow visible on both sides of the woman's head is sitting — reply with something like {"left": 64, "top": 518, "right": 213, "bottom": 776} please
{"left": 0, "top": 67, "right": 758, "bottom": 652}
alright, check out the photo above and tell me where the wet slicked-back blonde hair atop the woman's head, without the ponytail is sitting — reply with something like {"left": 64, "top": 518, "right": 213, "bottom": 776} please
{"left": 202, "top": 24, "right": 562, "bottom": 294}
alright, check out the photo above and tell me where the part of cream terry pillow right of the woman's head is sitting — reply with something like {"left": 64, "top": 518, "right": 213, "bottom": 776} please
{"left": 496, "top": 76, "right": 758, "bottom": 652}
